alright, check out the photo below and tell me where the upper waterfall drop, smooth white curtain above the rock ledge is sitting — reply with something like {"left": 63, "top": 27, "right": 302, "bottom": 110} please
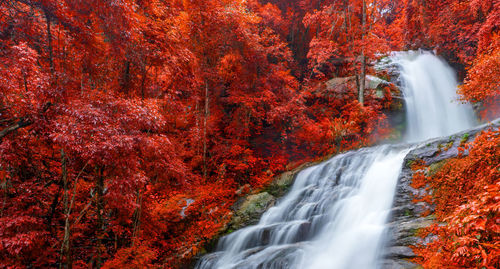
{"left": 392, "top": 51, "right": 476, "bottom": 142}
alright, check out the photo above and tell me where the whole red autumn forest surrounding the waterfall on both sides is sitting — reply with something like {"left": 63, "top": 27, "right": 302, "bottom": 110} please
{"left": 0, "top": 0, "right": 500, "bottom": 268}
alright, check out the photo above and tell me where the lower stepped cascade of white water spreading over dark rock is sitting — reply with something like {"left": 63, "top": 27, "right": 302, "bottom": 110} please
{"left": 198, "top": 145, "right": 407, "bottom": 269}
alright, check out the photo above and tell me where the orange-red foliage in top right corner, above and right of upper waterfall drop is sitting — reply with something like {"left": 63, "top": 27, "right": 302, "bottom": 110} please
{"left": 392, "top": 0, "right": 500, "bottom": 119}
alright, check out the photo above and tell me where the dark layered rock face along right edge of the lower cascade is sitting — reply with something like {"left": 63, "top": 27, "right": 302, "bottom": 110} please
{"left": 382, "top": 119, "right": 500, "bottom": 269}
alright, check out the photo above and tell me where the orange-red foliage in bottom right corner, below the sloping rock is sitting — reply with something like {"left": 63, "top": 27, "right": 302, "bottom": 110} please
{"left": 414, "top": 130, "right": 500, "bottom": 268}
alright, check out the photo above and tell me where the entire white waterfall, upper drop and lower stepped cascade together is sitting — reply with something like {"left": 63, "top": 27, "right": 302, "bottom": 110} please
{"left": 196, "top": 52, "right": 474, "bottom": 269}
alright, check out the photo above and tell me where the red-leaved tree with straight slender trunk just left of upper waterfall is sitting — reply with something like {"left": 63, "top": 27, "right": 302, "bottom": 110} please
{"left": 304, "top": 0, "right": 388, "bottom": 100}
